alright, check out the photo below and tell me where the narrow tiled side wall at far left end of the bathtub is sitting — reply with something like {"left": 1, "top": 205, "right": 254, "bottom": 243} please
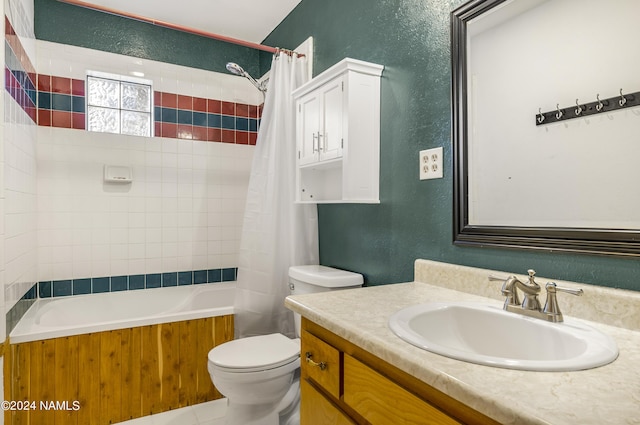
{"left": 0, "top": 0, "right": 37, "bottom": 339}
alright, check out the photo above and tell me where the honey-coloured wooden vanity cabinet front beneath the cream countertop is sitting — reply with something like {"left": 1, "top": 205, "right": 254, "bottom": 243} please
{"left": 300, "top": 317, "right": 497, "bottom": 425}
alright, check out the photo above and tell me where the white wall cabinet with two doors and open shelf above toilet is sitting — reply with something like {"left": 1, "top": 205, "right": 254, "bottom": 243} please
{"left": 293, "top": 58, "right": 383, "bottom": 203}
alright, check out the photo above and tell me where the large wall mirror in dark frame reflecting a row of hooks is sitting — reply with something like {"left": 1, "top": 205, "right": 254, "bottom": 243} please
{"left": 451, "top": 0, "right": 640, "bottom": 256}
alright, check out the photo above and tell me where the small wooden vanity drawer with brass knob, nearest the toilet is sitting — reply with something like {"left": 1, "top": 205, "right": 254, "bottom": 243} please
{"left": 300, "top": 331, "right": 340, "bottom": 399}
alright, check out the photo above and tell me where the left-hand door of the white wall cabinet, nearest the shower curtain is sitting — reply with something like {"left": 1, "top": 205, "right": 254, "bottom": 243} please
{"left": 297, "top": 92, "right": 321, "bottom": 165}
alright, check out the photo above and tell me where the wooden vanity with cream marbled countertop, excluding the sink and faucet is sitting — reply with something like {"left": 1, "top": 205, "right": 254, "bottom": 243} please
{"left": 285, "top": 260, "right": 640, "bottom": 425}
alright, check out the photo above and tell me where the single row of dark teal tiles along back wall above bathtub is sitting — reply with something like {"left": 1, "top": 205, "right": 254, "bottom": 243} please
{"left": 37, "top": 267, "right": 238, "bottom": 298}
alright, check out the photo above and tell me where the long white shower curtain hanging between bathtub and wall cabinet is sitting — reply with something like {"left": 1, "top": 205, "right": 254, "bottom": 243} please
{"left": 235, "top": 53, "right": 318, "bottom": 338}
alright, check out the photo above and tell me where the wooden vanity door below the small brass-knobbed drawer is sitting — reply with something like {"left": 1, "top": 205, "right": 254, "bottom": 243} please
{"left": 300, "top": 379, "right": 355, "bottom": 425}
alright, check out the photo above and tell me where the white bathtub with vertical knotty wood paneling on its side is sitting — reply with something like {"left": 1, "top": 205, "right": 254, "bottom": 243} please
{"left": 4, "top": 282, "right": 235, "bottom": 425}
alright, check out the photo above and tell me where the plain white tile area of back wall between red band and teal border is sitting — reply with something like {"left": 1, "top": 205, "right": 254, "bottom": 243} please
{"left": 37, "top": 126, "right": 253, "bottom": 281}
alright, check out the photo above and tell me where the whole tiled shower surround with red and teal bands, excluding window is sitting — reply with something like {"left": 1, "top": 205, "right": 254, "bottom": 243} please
{"left": 0, "top": 6, "right": 263, "bottom": 336}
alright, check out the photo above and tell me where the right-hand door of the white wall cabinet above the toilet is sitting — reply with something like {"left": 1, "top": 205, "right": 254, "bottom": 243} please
{"left": 319, "top": 78, "right": 344, "bottom": 161}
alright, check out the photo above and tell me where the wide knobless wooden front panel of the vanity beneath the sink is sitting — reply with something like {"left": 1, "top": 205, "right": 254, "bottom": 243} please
{"left": 344, "top": 354, "right": 460, "bottom": 425}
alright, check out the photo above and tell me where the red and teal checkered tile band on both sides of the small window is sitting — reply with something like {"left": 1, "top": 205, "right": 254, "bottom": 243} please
{"left": 5, "top": 15, "right": 263, "bottom": 145}
